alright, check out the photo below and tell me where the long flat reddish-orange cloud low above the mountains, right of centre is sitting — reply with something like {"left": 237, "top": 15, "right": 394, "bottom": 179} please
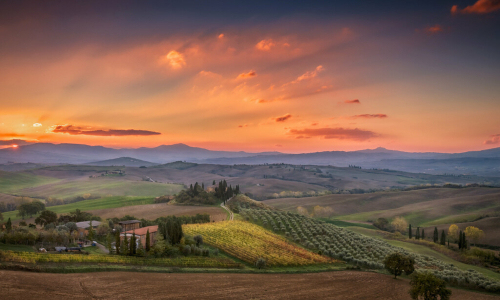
{"left": 289, "top": 127, "right": 378, "bottom": 141}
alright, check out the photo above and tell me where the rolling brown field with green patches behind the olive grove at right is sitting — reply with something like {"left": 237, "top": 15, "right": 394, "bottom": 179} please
{"left": 264, "top": 188, "right": 500, "bottom": 225}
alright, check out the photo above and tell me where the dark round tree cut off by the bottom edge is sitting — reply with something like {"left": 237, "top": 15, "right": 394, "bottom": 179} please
{"left": 410, "top": 272, "right": 451, "bottom": 300}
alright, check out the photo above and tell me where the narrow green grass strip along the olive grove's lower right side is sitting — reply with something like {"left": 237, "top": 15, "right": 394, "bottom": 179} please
{"left": 349, "top": 227, "right": 500, "bottom": 280}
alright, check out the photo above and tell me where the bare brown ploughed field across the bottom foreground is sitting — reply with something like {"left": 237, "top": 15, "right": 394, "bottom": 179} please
{"left": 0, "top": 271, "right": 499, "bottom": 300}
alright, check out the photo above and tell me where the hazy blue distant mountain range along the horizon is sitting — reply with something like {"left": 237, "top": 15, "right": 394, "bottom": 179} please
{"left": 0, "top": 143, "right": 500, "bottom": 177}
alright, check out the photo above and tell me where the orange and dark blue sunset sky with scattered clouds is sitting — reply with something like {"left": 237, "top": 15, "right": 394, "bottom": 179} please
{"left": 0, "top": 0, "right": 500, "bottom": 153}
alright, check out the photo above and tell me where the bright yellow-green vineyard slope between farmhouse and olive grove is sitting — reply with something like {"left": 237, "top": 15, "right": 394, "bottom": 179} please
{"left": 183, "top": 221, "right": 333, "bottom": 266}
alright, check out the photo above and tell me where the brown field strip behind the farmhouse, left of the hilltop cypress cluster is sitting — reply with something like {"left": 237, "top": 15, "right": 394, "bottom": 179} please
{"left": 89, "top": 203, "right": 227, "bottom": 221}
